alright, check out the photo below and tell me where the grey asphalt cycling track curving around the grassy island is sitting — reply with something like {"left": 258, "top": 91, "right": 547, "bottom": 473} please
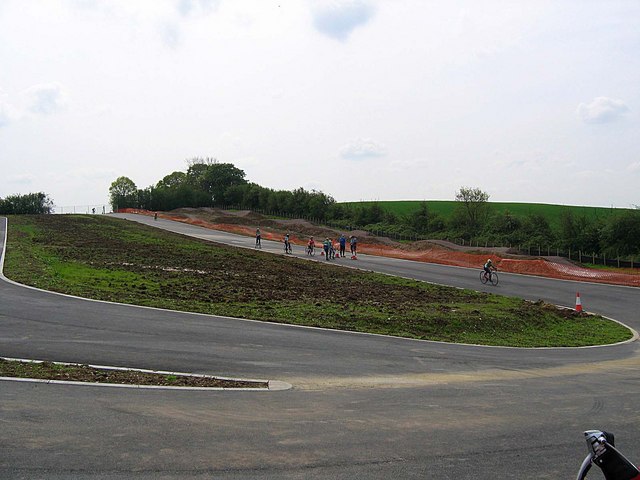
{"left": 0, "top": 216, "right": 640, "bottom": 480}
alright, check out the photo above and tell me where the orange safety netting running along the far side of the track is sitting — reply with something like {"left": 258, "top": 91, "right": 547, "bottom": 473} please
{"left": 118, "top": 208, "right": 640, "bottom": 287}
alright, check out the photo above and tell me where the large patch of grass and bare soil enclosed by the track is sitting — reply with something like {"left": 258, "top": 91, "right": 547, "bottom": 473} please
{"left": 5, "top": 215, "right": 631, "bottom": 347}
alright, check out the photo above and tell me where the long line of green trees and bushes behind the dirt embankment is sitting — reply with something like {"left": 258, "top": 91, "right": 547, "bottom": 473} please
{"left": 109, "top": 158, "right": 640, "bottom": 256}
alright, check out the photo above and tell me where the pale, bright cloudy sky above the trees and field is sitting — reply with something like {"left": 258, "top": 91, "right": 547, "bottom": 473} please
{"left": 0, "top": 0, "right": 640, "bottom": 208}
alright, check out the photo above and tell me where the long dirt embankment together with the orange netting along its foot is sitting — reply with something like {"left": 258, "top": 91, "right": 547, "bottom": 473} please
{"left": 119, "top": 208, "right": 640, "bottom": 287}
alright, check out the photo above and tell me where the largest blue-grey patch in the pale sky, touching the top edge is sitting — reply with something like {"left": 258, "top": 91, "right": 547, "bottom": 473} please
{"left": 311, "top": 0, "right": 375, "bottom": 41}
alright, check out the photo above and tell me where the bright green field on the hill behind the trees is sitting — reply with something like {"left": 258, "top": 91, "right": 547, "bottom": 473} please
{"left": 341, "top": 200, "right": 625, "bottom": 228}
